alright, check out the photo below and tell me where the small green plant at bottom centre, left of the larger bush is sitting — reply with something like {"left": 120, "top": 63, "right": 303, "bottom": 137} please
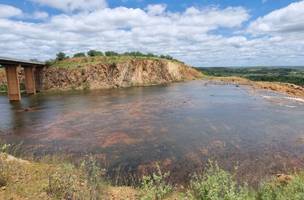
{"left": 141, "top": 165, "right": 173, "bottom": 200}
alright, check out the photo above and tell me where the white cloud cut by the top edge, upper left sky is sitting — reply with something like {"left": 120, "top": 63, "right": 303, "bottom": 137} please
{"left": 30, "top": 0, "right": 107, "bottom": 12}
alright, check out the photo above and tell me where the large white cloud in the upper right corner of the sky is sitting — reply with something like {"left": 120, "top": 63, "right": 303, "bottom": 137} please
{"left": 248, "top": 1, "right": 304, "bottom": 34}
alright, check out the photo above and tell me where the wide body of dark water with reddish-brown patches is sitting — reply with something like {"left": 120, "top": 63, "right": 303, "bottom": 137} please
{"left": 0, "top": 81, "right": 304, "bottom": 184}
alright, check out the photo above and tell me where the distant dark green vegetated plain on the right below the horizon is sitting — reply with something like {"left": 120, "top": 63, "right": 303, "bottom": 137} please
{"left": 197, "top": 67, "right": 304, "bottom": 86}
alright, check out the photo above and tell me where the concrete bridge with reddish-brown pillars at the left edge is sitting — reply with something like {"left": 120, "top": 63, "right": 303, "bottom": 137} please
{"left": 0, "top": 57, "right": 45, "bottom": 101}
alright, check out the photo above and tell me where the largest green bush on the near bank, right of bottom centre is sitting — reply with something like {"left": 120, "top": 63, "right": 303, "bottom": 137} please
{"left": 188, "top": 162, "right": 255, "bottom": 200}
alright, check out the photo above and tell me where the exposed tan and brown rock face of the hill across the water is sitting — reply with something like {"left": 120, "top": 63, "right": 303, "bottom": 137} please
{"left": 44, "top": 59, "right": 201, "bottom": 90}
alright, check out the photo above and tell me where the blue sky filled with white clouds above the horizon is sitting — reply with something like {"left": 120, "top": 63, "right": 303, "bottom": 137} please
{"left": 0, "top": 0, "right": 304, "bottom": 67}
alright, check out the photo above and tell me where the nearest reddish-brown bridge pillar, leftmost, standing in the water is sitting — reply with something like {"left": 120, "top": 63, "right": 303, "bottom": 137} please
{"left": 5, "top": 66, "right": 21, "bottom": 101}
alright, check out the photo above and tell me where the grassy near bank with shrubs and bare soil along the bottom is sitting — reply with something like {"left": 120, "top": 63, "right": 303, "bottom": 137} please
{"left": 0, "top": 153, "right": 304, "bottom": 200}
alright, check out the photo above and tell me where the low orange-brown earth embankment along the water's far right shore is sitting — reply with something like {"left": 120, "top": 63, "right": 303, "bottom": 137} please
{"left": 207, "top": 77, "right": 304, "bottom": 98}
